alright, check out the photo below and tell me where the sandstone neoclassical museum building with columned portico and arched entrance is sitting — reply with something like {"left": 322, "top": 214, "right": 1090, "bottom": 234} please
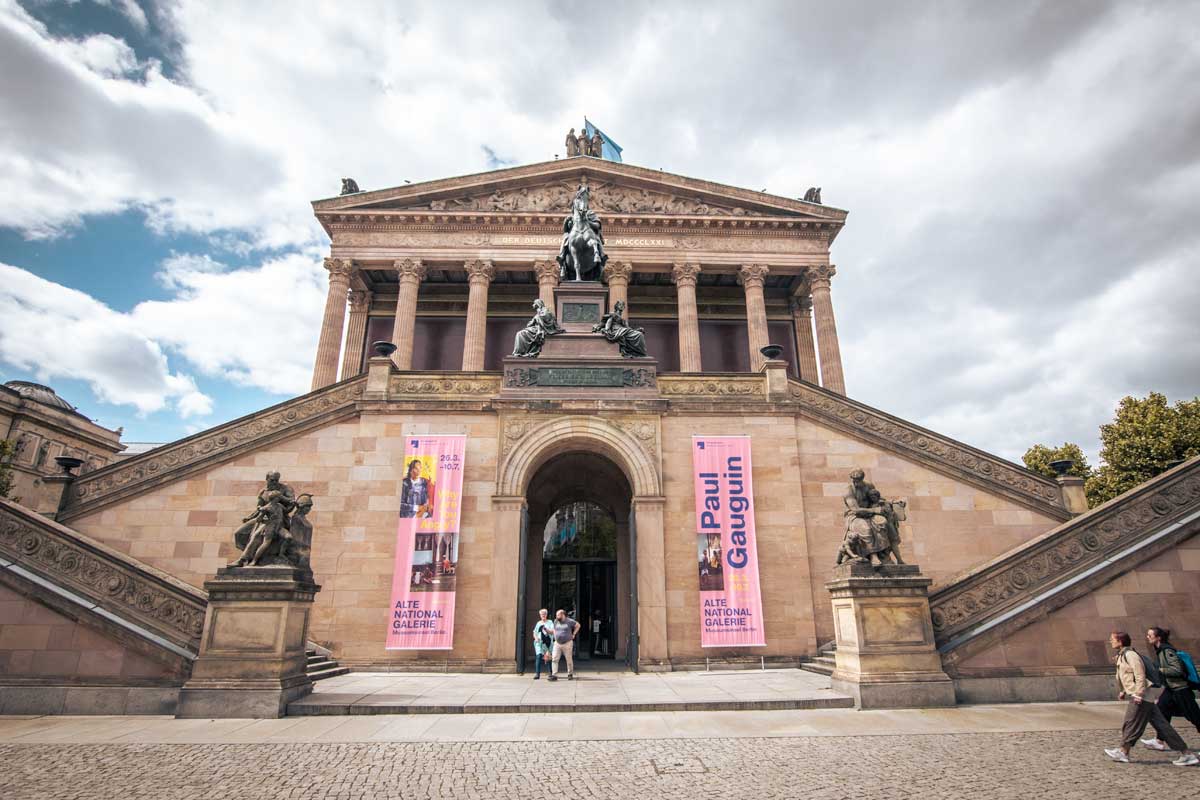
{"left": 0, "top": 157, "right": 1200, "bottom": 714}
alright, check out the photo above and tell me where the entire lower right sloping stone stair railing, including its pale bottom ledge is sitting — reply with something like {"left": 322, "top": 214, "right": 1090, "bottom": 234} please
{"left": 929, "top": 457, "right": 1200, "bottom": 668}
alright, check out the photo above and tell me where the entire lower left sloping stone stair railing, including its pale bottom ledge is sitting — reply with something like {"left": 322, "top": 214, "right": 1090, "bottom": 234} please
{"left": 0, "top": 500, "right": 208, "bottom": 661}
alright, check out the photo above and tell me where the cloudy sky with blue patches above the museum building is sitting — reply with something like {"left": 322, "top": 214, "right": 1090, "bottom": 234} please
{"left": 0, "top": 0, "right": 1200, "bottom": 459}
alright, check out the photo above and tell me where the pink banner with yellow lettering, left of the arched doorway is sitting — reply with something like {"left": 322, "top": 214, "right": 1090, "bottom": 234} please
{"left": 388, "top": 435, "right": 467, "bottom": 650}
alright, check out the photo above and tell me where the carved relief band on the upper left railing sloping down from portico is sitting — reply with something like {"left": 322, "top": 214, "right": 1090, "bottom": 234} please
{"left": 67, "top": 375, "right": 366, "bottom": 516}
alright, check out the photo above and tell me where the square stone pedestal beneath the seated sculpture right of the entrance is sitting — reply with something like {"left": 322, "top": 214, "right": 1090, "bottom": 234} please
{"left": 826, "top": 563, "right": 955, "bottom": 709}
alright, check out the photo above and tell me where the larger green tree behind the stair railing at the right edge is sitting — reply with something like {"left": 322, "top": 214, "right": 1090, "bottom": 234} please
{"left": 1085, "top": 392, "right": 1200, "bottom": 506}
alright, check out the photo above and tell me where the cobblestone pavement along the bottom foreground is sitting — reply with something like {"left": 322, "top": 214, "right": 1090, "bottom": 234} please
{"left": 0, "top": 730, "right": 1200, "bottom": 800}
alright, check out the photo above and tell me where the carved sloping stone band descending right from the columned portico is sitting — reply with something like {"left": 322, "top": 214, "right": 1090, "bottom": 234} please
{"left": 788, "top": 380, "right": 1067, "bottom": 519}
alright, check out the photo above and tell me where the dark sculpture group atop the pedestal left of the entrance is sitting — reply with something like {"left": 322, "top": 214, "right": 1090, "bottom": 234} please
{"left": 229, "top": 471, "right": 312, "bottom": 570}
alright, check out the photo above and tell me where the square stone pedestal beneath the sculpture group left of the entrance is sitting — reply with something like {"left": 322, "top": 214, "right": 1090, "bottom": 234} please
{"left": 178, "top": 566, "right": 320, "bottom": 717}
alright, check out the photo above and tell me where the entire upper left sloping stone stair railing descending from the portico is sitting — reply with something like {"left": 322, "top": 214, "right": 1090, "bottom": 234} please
{"left": 59, "top": 375, "right": 366, "bottom": 519}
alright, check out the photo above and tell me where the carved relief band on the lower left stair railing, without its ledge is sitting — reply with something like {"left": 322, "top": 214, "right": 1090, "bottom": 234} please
{"left": 0, "top": 505, "right": 206, "bottom": 652}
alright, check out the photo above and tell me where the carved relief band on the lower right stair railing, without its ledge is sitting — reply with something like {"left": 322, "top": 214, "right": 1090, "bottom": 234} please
{"left": 930, "top": 462, "right": 1200, "bottom": 643}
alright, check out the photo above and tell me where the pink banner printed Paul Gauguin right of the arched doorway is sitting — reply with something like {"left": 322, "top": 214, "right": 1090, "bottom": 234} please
{"left": 691, "top": 437, "right": 767, "bottom": 648}
